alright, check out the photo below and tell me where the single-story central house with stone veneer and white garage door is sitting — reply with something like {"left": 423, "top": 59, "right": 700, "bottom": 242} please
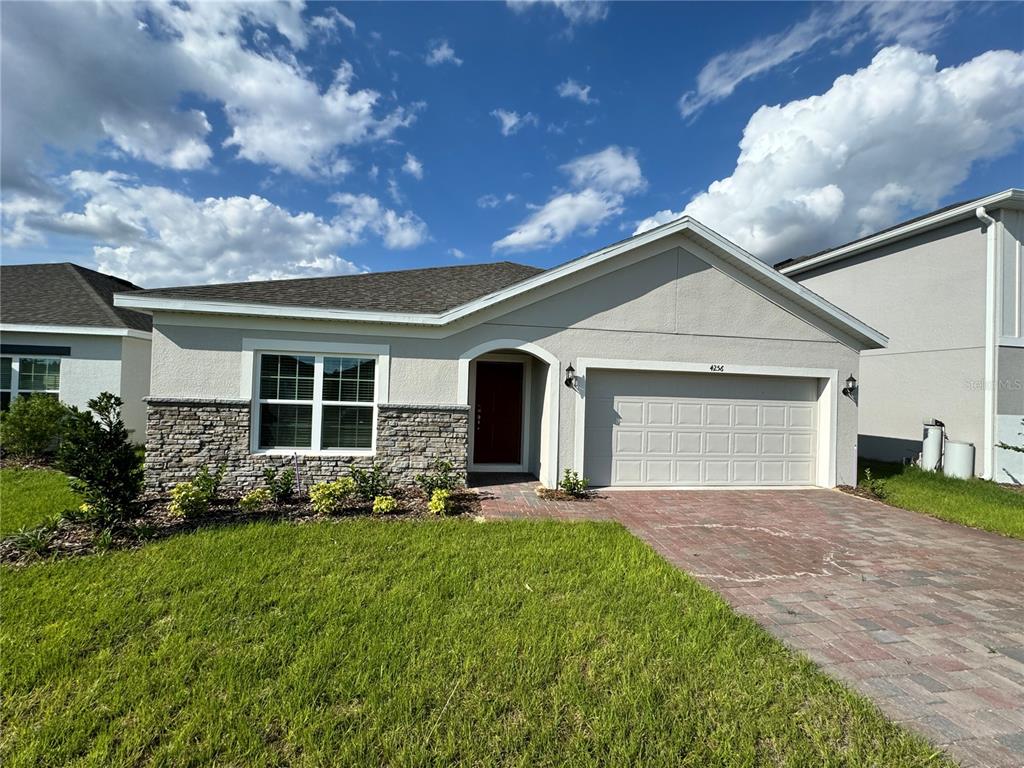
{"left": 115, "top": 217, "right": 886, "bottom": 488}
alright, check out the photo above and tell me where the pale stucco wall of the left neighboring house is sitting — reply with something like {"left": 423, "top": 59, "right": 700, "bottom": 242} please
{"left": 2, "top": 331, "right": 151, "bottom": 442}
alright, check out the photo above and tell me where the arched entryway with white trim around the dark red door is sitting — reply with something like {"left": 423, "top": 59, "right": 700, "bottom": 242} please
{"left": 459, "top": 339, "right": 561, "bottom": 487}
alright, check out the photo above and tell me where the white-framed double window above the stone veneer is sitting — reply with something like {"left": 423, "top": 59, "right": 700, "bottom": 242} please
{"left": 253, "top": 352, "right": 379, "bottom": 454}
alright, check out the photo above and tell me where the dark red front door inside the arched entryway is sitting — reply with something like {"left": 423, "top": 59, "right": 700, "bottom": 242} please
{"left": 473, "top": 360, "right": 522, "bottom": 464}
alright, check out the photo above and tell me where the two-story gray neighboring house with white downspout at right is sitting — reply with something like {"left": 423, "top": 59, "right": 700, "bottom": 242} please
{"left": 776, "top": 189, "right": 1024, "bottom": 482}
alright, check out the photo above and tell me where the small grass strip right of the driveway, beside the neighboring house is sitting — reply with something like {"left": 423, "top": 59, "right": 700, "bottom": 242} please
{"left": 860, "top": 462, "right": 1024, "bottom": 539}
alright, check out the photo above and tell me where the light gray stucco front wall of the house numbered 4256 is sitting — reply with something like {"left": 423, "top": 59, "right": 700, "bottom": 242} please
{"left": 152, "top": 244, "right": 858, "bottom": 483}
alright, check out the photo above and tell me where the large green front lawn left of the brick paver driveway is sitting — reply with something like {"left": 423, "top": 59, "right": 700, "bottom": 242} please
{"left": 0, "top": 520, "right": 946, "bottom": 768}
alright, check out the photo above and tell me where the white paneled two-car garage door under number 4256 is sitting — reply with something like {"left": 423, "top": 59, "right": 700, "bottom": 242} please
{"left": 584, "top": 370, "right": 818, "bottom": 486}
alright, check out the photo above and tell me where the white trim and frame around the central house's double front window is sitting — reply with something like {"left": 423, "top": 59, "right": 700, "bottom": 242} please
{"left": 241, "top": 339, "right": 390, "bottom": 457}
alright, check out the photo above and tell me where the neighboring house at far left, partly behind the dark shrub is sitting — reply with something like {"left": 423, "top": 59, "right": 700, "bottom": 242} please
{"left": 0, "top": 263, "right": 153, "bottom": 442}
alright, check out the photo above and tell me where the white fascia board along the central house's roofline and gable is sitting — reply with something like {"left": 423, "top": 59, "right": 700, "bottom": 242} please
{"left": 114, "top": 216, "right": 889, "bottom": 347}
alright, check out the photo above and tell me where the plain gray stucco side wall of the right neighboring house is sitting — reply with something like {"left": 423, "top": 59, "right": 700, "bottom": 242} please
{"left": 794, "top": 219, "right": 986, "bottom": 469}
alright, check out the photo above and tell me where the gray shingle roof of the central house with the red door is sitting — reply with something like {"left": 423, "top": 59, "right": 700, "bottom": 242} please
{"left": 121, "top": 261, "right": 544, "bottom": 313}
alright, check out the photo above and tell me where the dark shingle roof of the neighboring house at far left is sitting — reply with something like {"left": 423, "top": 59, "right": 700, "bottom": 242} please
{"left": 0, "top": 262, "right": 153, "bottom": 331}
